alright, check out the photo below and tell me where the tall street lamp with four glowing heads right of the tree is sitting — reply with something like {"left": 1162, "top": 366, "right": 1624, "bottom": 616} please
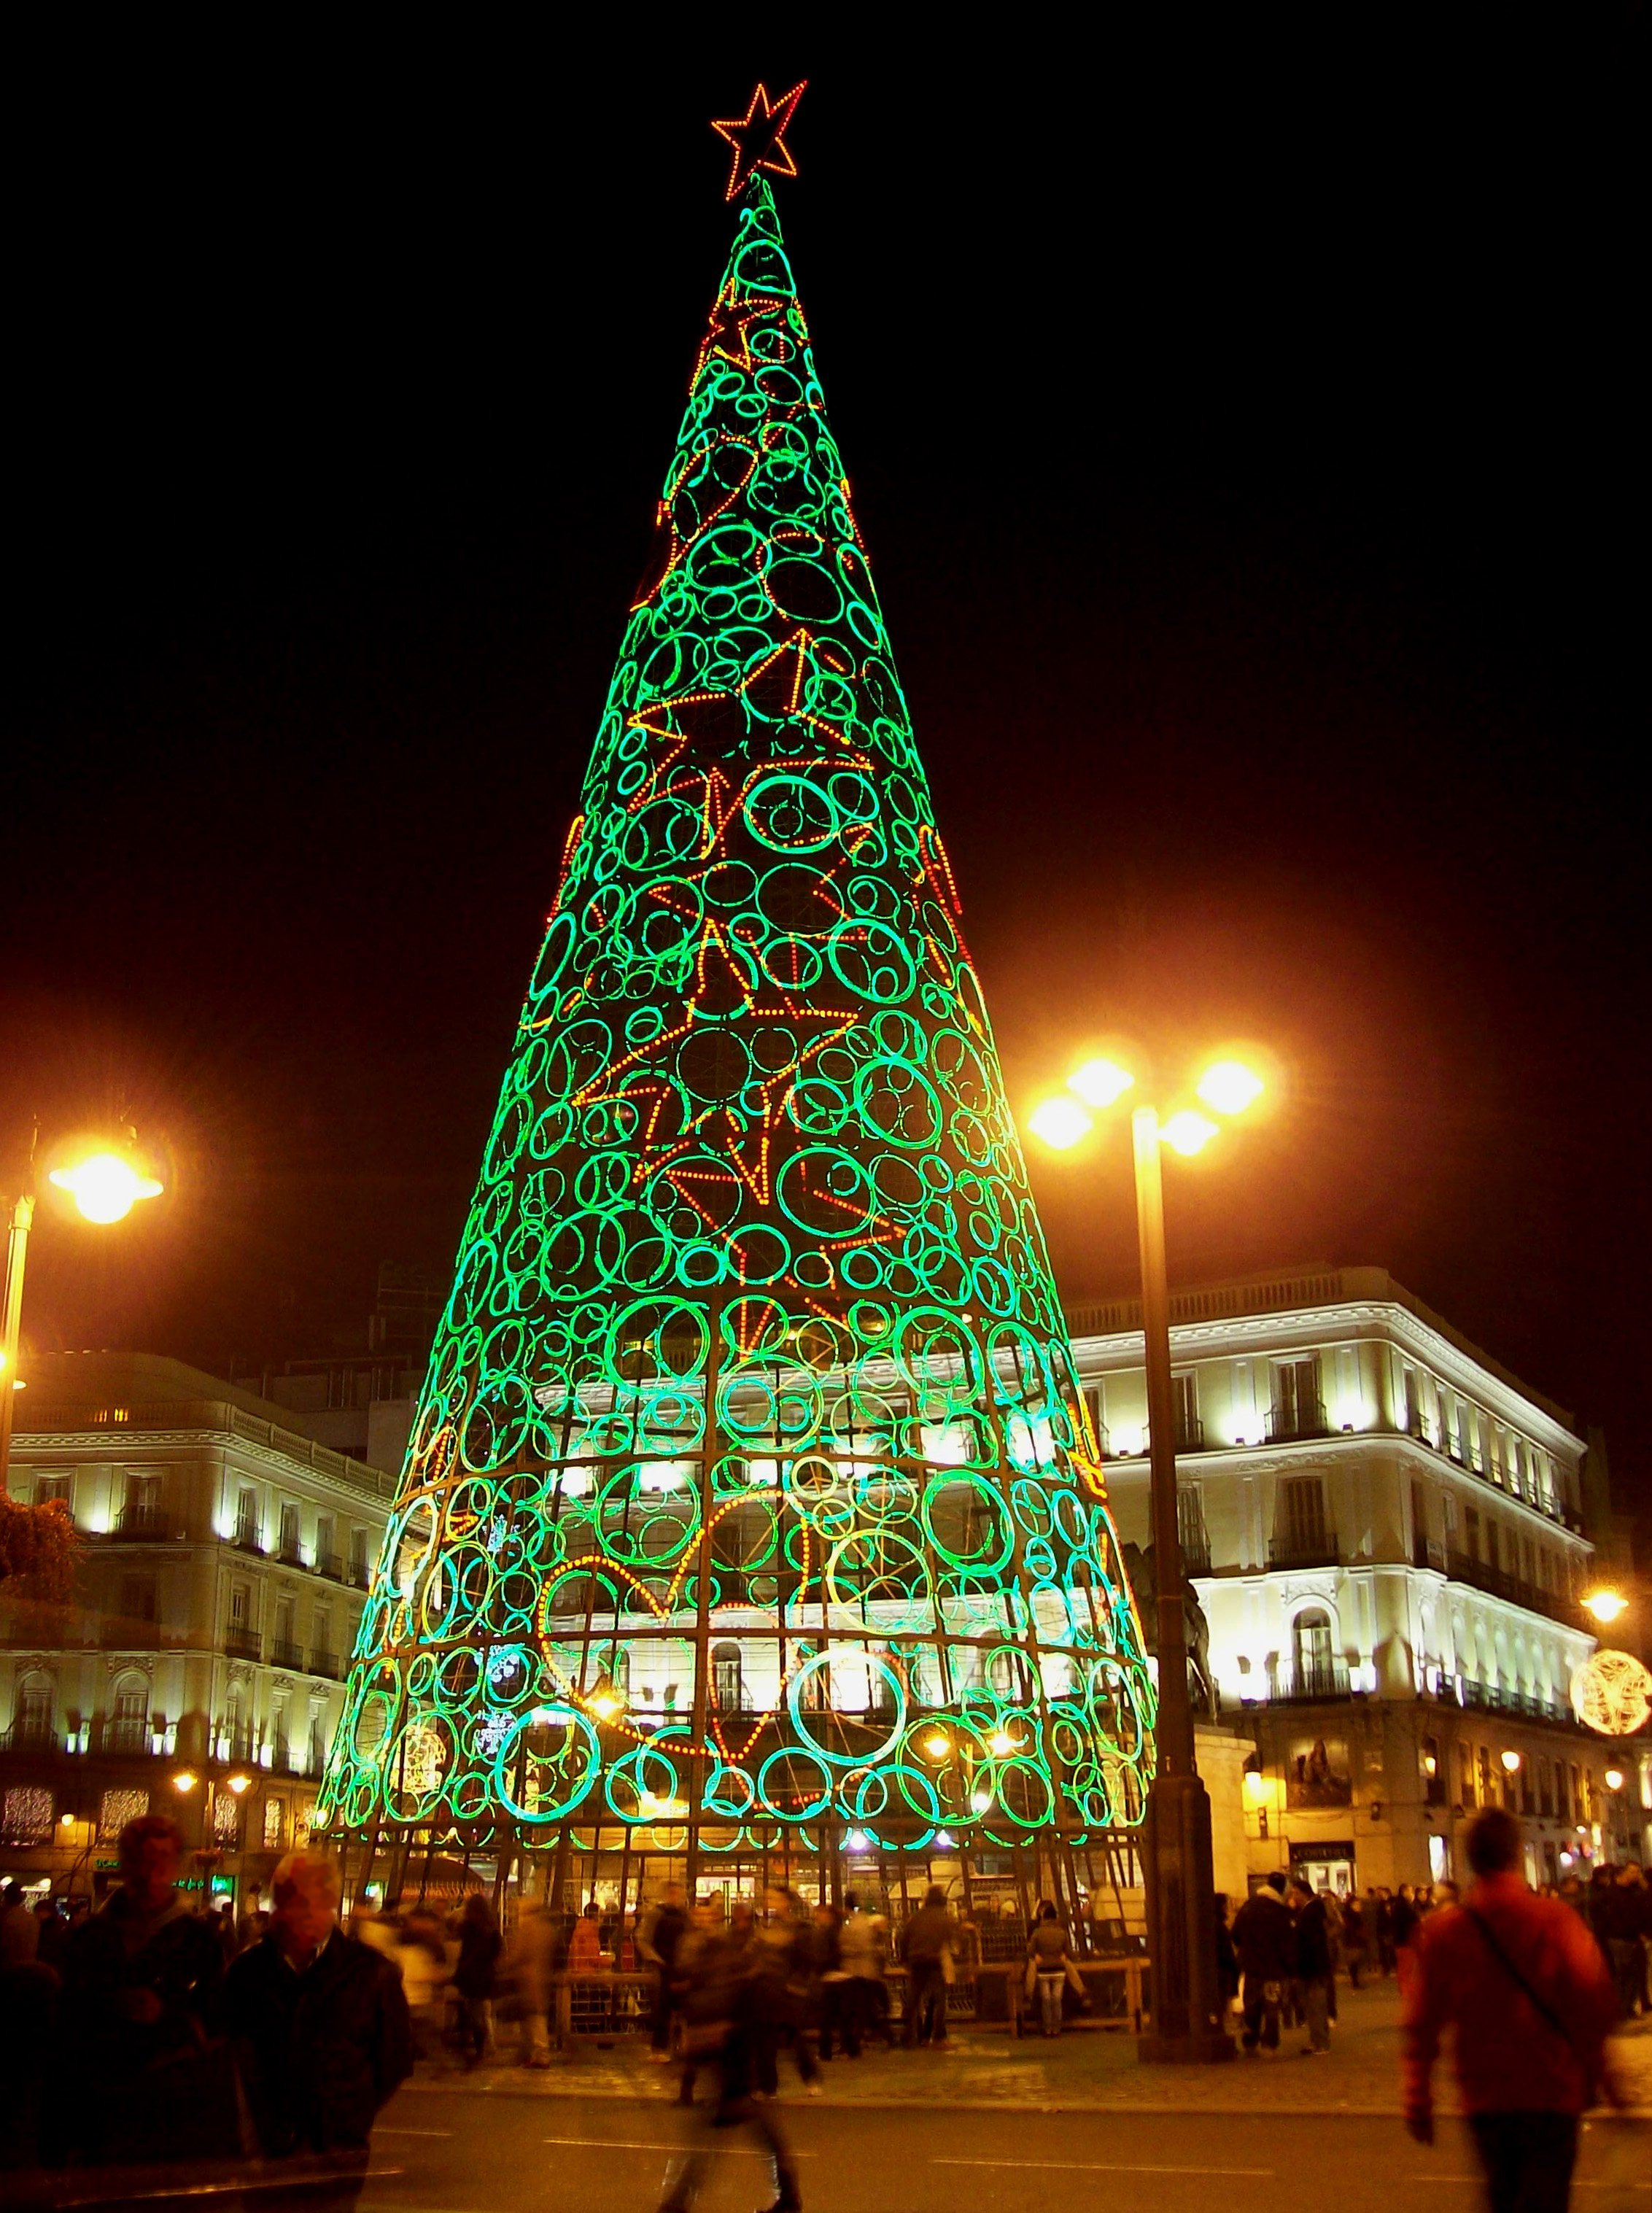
{"left": 1028, "top": 1058, "right": 1265, "bottom": 2061}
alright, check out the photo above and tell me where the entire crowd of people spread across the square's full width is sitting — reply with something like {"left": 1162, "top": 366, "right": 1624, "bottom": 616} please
{"left": 0, "top": 1808, "right": 1652, "bottom": 2213}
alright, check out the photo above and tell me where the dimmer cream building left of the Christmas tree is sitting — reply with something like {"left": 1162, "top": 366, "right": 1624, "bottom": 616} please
{"left": 0, "top": 1354, "right": 394, "bottom": 1892}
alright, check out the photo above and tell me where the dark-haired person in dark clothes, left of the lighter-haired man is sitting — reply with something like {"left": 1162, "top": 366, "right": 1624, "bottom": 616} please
{"left": 49, "top": 1815, "right": 228, "bottom": 2162}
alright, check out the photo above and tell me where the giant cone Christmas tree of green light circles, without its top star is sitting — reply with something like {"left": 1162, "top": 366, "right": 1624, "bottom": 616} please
{"left": 317, "top": 160, "right": 1155, "bottom": 1864}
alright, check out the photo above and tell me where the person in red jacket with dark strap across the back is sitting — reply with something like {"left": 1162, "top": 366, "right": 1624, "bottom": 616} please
{"left": 1404, "top": 1806, "right": 1616, "bottom": 2213}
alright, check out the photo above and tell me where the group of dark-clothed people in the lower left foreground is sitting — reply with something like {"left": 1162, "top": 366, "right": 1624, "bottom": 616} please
{"left": 0, "top": 1815, "right": 414, "bottom": 2213}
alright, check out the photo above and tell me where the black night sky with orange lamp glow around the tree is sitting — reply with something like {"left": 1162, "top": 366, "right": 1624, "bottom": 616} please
{"left": 0, "top": 39, "right": 1652, "bottom": 1540}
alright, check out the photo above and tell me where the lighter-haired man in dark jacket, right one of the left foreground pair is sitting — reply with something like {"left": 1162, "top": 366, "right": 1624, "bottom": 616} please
{"left": 223, "top": 1852, "right": 414, "bottom": 2213}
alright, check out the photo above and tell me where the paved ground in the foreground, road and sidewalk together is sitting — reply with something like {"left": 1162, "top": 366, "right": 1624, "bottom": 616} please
{"left": 360, "top": 1985, "right": 1652, "bottom": 2213}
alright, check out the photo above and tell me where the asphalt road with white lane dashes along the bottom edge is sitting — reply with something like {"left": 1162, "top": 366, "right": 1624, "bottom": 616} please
{"left": 360, "top": 2087, "right": 1652, "bottom": 2213}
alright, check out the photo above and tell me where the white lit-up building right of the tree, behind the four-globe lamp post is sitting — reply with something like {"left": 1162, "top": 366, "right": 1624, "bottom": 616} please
{"left": 1069, "top": 1268, "right": 1652, "bottom": 1888}
